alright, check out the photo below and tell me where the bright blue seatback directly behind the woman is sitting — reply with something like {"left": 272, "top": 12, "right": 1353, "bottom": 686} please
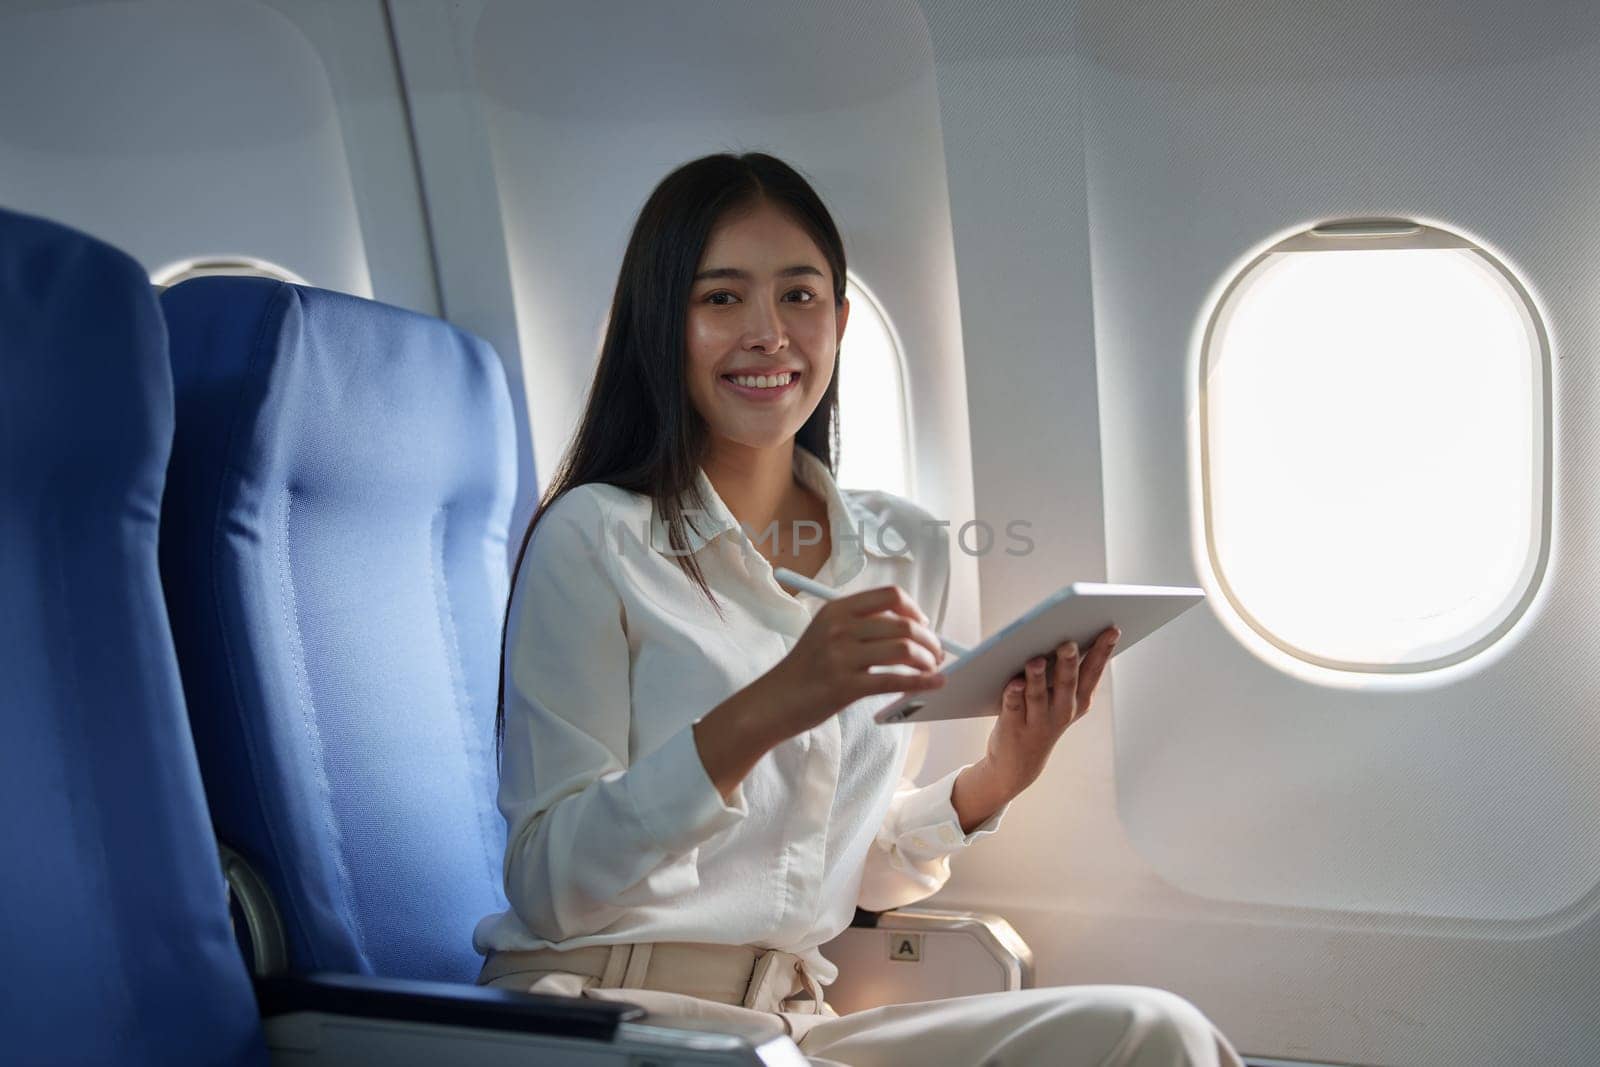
{"left": 162, "top": 278, "right": 515, "bottom": 981}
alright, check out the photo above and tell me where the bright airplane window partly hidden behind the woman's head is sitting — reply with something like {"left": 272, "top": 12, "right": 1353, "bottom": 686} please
{"left": 838, "top": 277, "right": 914, "bottom": 498}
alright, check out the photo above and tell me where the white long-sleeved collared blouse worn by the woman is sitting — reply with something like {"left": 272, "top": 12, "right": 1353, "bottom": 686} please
{"left": 474, "top": 445, "right": 1005, "bottom": 984}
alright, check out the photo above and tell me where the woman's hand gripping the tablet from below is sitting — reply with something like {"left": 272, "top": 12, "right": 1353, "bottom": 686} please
{"left": 973, "top": 625, "right": 1122, "bottom": 797}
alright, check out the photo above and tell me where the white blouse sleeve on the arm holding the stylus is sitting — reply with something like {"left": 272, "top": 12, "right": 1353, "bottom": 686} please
{"left": 499, "top": 486, "right": 749, "bottom": 941}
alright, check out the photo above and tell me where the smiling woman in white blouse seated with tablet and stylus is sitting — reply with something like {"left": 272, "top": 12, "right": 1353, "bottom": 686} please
{"left": 475, "top": 154, "right": 1238, "bottom": 1067}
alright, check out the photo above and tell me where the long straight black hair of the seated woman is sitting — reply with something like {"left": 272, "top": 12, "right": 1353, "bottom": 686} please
{"left": 494, "top": 152, "right": 845, "bottom": 764}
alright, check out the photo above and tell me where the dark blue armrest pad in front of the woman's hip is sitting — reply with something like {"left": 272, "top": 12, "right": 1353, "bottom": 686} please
{"left": 256, "top": 974, "right": 645, "bottom": 1041}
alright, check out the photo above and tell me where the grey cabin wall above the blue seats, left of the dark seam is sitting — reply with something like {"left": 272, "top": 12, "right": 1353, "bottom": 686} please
{"left": 0, "top": 0, "right": 434, "bottom": 310}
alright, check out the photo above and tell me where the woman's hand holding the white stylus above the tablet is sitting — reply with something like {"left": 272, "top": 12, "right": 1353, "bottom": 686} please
{"left": 757, "top": 585, "right": 944, "bottom": 737}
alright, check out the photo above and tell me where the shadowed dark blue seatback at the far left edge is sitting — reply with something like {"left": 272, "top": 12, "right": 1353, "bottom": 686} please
{"left": 0, "top": 210, "right": 266, "bottom": 1064}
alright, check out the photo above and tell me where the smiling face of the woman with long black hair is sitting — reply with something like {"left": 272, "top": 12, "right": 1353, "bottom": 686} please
{"left": 688, "top": 202, "right": 850, "bottom": 448}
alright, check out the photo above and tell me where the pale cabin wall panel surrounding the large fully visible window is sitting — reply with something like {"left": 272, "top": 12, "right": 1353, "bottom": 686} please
{"left": 922, "top": 0, "right": 1600, "bottom": 1065}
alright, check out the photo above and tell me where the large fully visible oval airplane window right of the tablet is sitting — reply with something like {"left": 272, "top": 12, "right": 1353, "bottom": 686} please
{"left": 1198, "top": 219, "right": 1550, "bottom": 673}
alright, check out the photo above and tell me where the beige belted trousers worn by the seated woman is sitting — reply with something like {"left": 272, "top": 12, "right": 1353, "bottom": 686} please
{"left": 478, "top": 942, "right": 1243, "bottom": 1067}
